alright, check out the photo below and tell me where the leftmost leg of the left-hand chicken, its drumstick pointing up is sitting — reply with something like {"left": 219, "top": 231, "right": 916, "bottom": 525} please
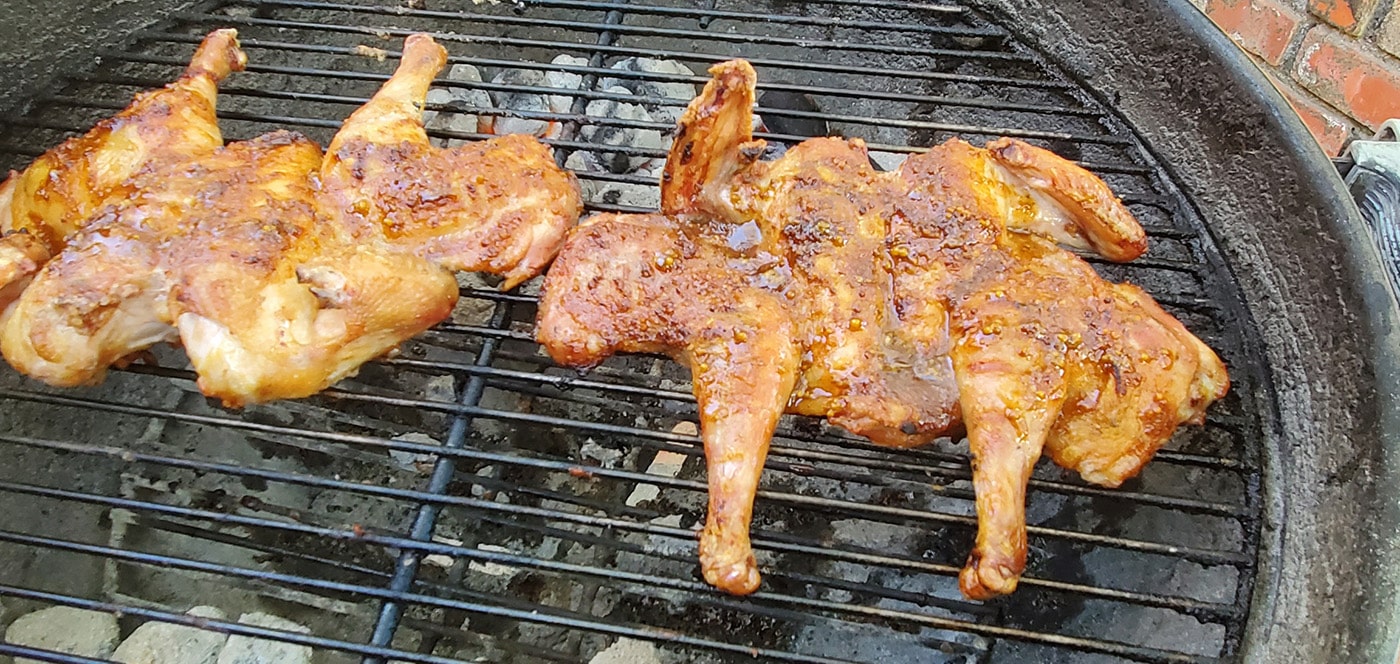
{"left": 0, "top": 29, "right": 246, "bottom": 308}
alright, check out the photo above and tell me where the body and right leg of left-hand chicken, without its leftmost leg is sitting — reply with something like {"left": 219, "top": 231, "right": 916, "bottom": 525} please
{"left": 0, "top": 35, "right": 581, "bottom": 406}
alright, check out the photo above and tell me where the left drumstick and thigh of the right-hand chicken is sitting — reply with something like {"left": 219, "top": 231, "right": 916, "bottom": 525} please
{"left": 536, "top": 214, "right": 801, "bottom": 593}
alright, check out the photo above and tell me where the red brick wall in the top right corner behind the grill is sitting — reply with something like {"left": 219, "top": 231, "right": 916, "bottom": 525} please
{"left": 1193, "top": 0, "right": 1400, "bottom": 154}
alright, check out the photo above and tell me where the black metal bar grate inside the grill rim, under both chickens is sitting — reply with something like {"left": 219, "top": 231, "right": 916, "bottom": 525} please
{"left": 0, "top": 0, "right": 1266, "bottom": 663}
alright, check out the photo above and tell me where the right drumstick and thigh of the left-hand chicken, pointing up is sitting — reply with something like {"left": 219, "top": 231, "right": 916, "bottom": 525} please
{"left": 321, "top": 35, "right": 582, "bottom": 290}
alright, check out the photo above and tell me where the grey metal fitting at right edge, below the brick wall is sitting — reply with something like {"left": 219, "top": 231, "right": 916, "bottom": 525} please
{"left": 1345, "top": 119, "right": 1400, "bottom": 290}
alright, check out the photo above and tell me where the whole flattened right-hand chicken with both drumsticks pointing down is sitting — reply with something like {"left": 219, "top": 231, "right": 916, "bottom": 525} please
{"left": 538, "top": 60, "right": 1229, "bottom": 598}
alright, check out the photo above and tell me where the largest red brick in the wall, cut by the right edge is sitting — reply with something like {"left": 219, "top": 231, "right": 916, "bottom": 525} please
{"left": 1294, "top": 25, "right": 1400, "bottom": 129}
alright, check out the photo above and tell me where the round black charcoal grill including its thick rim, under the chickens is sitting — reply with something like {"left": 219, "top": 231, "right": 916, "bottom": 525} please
{"left": 0, "top": 0, "right": 1400, "bottom": 663}
